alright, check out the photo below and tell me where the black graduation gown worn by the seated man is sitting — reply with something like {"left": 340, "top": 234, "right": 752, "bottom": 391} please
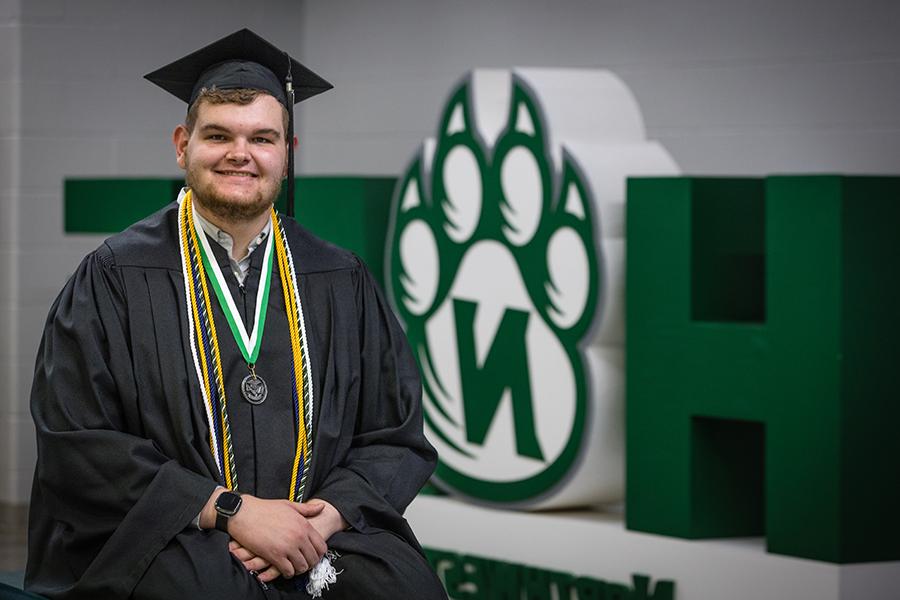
{"left": 25, "top": 203, "right": 441, "bottom": 598}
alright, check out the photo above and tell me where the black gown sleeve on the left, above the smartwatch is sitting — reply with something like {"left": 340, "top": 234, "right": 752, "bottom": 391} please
{"left": 25, "top": 246, "right": 216, "bottom": 598}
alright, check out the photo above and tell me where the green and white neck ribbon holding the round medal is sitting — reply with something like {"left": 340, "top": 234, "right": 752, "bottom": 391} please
{"left": 192, "top": 207, "right": 275, "bottom": 372}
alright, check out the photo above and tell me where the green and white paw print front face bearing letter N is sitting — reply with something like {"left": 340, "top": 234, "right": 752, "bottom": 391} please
{"left": 387, "top": 69, "right": 676, "bottom": 506}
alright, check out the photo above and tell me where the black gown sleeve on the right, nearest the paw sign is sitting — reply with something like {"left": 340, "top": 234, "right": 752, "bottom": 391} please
{"left": 313, "top": 266, "right": 437, "bottom": 547}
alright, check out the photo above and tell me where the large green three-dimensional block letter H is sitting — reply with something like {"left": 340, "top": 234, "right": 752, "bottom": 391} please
{"left": 626, "top": 176, "right": 900, "bottom": 563}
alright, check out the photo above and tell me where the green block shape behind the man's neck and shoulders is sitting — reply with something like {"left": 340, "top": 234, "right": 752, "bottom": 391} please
{"left": 64, "top": 177, "right": 397, "bottom": 285}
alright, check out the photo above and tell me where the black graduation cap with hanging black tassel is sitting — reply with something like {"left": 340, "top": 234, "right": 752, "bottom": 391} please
{"left": 144, "top": 29, "right": 333, "bottom": 216}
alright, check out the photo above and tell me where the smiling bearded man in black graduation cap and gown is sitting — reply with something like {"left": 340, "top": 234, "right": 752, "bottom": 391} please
{"left": 26, "top": 30, "right": 446, "bottom": 599}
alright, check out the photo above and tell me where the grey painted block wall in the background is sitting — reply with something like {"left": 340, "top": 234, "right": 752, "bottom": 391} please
{"left": 0, "top": 0, "right": 900, "bottom": 503}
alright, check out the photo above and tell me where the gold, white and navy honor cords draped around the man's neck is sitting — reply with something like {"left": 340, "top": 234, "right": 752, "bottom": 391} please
{"left": 179, "top": 190, "right": 312, "bottom": 502}
